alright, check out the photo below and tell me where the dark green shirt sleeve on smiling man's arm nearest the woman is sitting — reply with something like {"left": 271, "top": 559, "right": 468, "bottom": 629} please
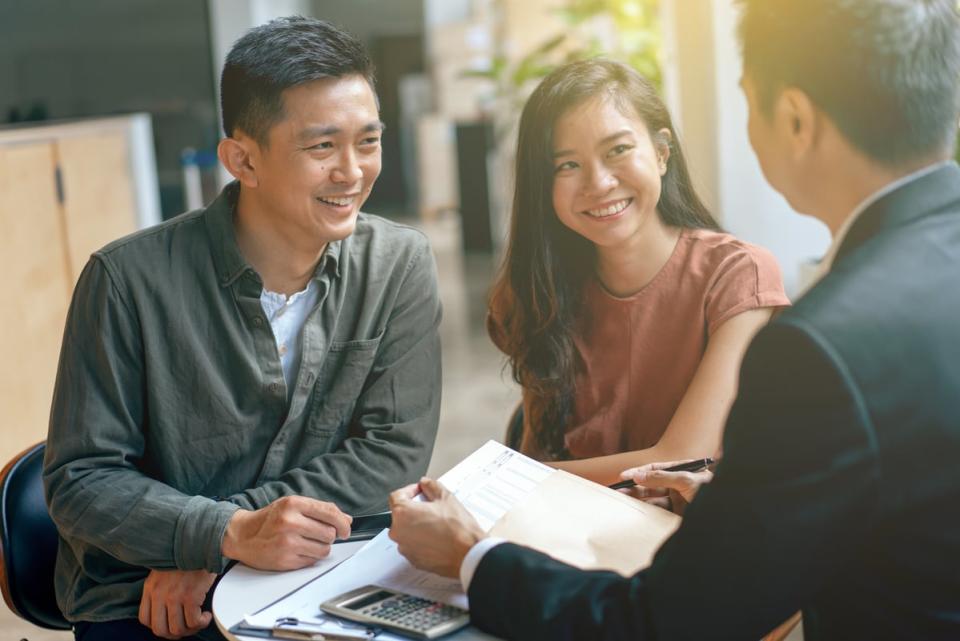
{"left": 229, "top": 239, "right": 441, "bottom": 514}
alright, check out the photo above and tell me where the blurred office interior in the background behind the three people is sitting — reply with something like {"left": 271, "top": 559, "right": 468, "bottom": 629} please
{"left": 0, "top": 0, "right": 856, "bottom": 639}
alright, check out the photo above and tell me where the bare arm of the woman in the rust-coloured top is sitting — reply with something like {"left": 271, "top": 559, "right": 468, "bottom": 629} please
{"left": 549, "top": 307, "right": 774, "bottom": 485}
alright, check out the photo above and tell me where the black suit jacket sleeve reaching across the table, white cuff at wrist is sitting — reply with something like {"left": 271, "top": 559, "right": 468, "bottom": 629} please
{"left": 469, "top": 321, "right": 879, "bottom": 639}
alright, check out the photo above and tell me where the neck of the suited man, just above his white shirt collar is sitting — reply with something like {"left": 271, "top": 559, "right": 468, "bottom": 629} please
{"left": 813, "top": 155, "right": 946, "bottom": 238}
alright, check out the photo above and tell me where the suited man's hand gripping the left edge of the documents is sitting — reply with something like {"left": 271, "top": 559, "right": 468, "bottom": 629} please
{"left": 390, "top": 478, "right": 484, "bottom": 578}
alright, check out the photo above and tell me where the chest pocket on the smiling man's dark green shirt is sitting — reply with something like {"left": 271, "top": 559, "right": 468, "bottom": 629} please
{"left": 307, "top": 332, "right": 383, "bottom": 437}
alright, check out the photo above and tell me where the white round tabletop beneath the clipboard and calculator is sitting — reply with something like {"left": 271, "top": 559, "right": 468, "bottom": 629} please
{"left": 213, "top": 541, "right": 497, "bottom": 641}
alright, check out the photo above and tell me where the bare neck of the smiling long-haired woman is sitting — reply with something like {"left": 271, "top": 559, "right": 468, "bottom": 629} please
{"left": 597, "top": 214, "right": 680, "bottom": 298}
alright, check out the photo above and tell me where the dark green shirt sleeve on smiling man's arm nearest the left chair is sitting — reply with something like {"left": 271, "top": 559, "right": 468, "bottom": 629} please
{"left": 44, "top": 256, "right": 237, "bottom": 572}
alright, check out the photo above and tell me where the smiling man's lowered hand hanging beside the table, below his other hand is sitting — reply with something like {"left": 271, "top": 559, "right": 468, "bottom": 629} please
{"left": 138, "top": 570, "right": 217, "bottom": 639}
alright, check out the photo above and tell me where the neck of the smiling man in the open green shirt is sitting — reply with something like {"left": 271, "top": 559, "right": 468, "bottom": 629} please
{"left": 234, "top": 189, "right": 326, "bottom": 296}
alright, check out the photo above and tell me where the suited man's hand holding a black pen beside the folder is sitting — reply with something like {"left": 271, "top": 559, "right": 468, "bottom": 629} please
{"left": 610, "top": 458, "right": 714, "bottom": 514}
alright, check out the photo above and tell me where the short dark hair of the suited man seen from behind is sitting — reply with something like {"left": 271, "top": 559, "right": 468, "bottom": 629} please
{"left": 738, "top": 0, "right": 960, "bottom": 166}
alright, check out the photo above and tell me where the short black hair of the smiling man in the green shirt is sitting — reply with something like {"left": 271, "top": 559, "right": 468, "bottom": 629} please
{"left": 220, "top": 16, "right": 374, "bottom": 145}
